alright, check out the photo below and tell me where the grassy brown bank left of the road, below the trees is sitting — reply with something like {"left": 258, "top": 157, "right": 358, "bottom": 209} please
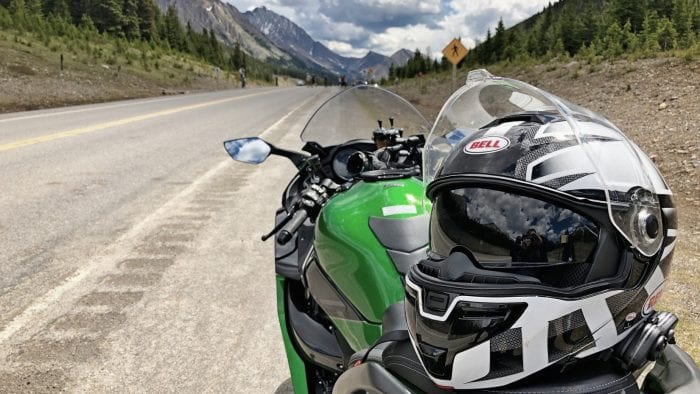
{"left": 0, "top": 31, "right": 246, "bottom": 113}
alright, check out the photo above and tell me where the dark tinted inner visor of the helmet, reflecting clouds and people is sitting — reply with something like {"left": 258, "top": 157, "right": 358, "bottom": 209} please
{"left": 431, "top": 188, "right": 598, "bottom": 268}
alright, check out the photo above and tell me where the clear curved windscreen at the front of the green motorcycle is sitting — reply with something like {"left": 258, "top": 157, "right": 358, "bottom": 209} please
{"left": 301, "top": 85, "right": 430, "bottom": 146}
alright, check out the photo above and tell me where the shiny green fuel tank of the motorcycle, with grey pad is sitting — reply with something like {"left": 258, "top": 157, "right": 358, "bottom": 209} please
{"left": 314, "top": 178, "right": 430, "bottom": 350}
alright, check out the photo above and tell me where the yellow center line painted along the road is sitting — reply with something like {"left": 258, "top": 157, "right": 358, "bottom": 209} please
{"left": 0, "top": 92, "right": 270, "bottom": 152}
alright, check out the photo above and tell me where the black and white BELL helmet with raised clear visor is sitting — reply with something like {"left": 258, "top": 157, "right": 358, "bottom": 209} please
{"left": 405, "top": 70, "right": 677, "bottom": 389}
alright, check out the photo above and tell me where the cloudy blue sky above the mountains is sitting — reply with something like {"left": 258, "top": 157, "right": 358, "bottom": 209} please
{"left": 225, "top": 0, "right": 555, "bottom": 57}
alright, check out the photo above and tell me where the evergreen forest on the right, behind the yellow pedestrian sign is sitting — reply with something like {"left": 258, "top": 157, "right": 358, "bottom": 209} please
{"left": 389, "top": 0, "right": 700, "bottom": 80}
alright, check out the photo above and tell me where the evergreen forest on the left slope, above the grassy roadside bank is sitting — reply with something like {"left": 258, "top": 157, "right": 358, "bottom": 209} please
{"left": 0, "top": 0, "right": 304, "bottom": 81}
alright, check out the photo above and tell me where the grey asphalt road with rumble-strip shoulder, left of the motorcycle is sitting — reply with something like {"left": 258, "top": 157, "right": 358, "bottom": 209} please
{"left": 0, "top": 88, "right": 340, "bottom": 393}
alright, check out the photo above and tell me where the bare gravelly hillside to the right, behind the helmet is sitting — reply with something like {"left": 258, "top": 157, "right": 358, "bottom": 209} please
{"left": 392, "top": 58, "right": 700, "bottom": 360}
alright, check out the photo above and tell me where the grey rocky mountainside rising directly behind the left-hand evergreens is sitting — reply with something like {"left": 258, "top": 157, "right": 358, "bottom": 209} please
{"left": 156, "top": 0, "right": 293, "bottom": 63}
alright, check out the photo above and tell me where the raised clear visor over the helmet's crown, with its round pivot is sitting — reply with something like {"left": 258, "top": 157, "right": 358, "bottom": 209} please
{"left": 423, "top": 70, "right": 670, "bottom": 256}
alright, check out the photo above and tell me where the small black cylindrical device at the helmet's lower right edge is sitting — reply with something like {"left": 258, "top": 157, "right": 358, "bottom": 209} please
{"left": 613, "top": 312, "right": 678, "bottom": 371}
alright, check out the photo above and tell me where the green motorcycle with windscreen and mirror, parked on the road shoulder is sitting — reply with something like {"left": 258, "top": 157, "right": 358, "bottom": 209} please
{"left": 224, "top": 85, "right": 430, "bottom": 393}
